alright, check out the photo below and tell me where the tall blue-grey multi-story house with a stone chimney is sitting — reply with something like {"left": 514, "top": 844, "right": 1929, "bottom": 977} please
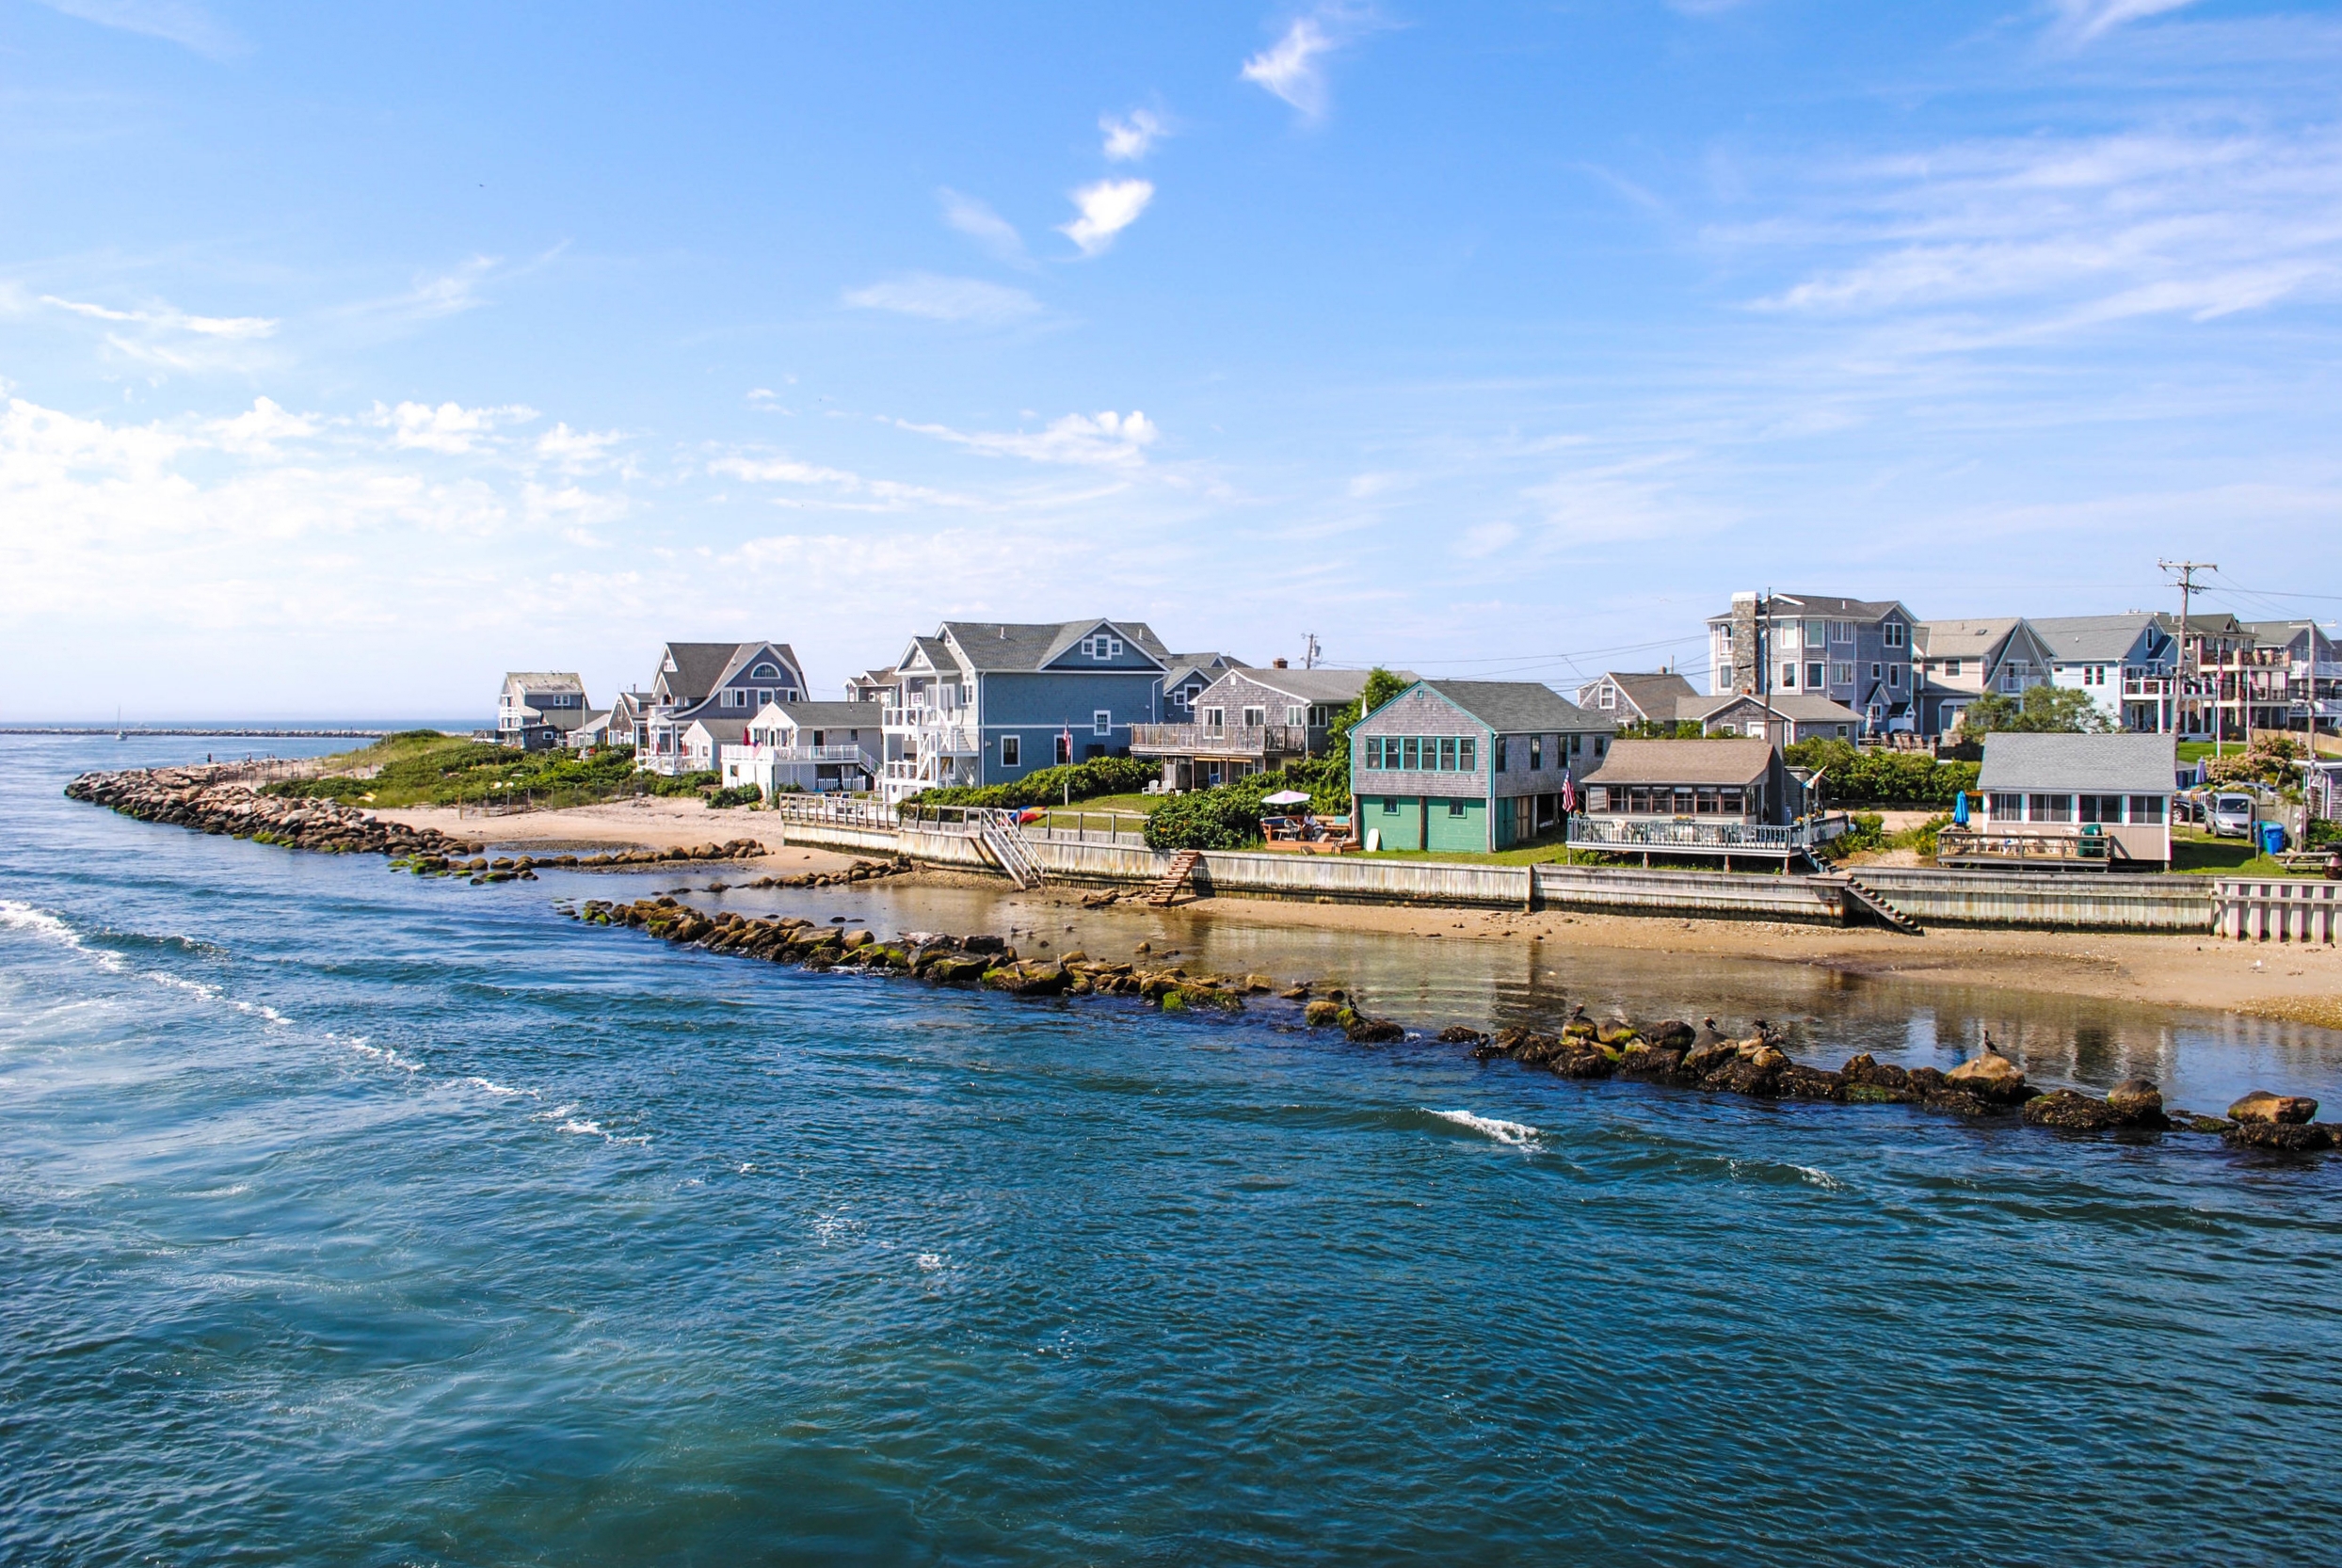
{"left": 1708, "top": 592, "right": 1918, "bottom": 735}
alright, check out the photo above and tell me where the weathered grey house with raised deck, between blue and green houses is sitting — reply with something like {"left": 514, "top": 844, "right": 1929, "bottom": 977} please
{"left": 1131, "top": 660, "right": 1415, "bottom": 791}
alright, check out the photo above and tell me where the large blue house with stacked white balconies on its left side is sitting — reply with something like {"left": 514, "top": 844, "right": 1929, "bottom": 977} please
{"left": 878, "top": 620, "right": 1173, "bottom": 800}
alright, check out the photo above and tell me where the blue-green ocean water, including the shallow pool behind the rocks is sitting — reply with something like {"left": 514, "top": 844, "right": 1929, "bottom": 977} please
{"left": 0, "top": 740, "right": 2342, "bottom": 1563}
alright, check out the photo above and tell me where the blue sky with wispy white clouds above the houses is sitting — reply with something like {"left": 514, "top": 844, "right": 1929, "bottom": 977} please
{"left": 0, "top": 0, "right": 2342, "bottom": 718}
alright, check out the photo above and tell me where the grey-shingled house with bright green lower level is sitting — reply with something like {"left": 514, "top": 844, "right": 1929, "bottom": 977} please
{"left": 1349, "top": 681, "right": 1616, "bottom": 852}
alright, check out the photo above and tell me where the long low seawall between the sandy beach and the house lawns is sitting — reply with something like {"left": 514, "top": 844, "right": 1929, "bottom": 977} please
{"left": 784, "top": 822, "right": 2218, "bottom": 934}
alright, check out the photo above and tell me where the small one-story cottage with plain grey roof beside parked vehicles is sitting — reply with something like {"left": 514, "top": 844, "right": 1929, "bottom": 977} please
{"left": 1937, "top": 730, "right": 2178, "bottom": 871}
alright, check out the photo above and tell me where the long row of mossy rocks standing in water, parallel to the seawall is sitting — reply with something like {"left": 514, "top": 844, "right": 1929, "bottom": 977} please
{"left": 562, "top": 896, "right": 2342, "bottom": 1154}
